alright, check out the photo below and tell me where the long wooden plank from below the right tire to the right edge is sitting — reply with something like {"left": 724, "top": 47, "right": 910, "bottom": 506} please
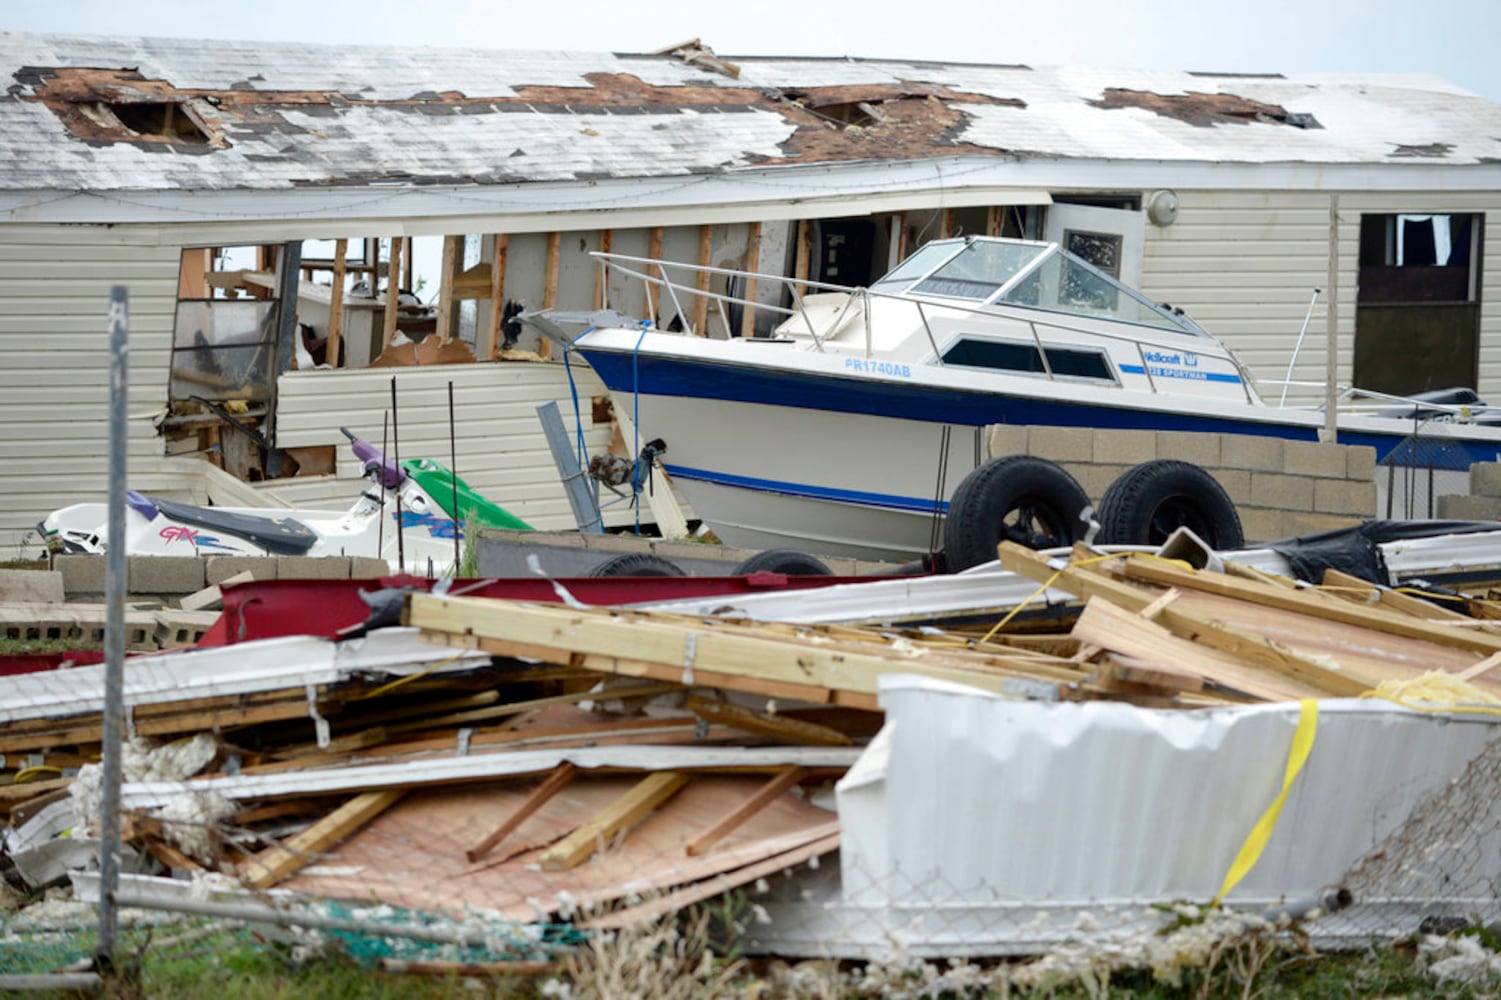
{"left": 1124, "top": 556, "right": 1501, "bottom": 655}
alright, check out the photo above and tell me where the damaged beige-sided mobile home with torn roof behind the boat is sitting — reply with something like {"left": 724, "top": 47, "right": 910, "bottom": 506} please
{"left": 0, "top": 33, "right": 1501, "bottom": 551}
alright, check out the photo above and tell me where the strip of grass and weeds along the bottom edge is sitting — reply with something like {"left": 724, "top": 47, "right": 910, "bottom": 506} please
{"left": 0, "top": 910, "right": 1501, "bottom": 1000}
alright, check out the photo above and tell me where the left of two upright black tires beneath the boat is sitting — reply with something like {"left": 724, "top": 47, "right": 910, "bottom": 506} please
{"left": 943, "top": 455, "right": 1090, "bottom": 572}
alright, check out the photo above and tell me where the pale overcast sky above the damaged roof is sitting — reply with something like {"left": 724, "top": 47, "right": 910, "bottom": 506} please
{"left": 0, "top": 0, "right": 1501, "bottom": 101}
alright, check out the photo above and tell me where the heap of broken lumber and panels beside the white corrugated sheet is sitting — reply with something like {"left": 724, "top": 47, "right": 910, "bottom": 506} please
{"left": 0, "top": 544, "right": 1501, "bottom": 960}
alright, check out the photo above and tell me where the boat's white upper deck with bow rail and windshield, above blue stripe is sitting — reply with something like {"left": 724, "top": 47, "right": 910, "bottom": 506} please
{"left": 519, "top": 239, "right": 1262, "bottom": 405}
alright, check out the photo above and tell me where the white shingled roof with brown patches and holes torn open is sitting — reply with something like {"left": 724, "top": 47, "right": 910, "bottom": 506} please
{"left": 0, "top": 33, "right": 1501, "bottom": 192}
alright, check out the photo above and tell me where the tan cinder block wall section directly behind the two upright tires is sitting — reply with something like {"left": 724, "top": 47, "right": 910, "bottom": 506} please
{"left": 986, "top": 425, "right": 1374, "bottom": 544}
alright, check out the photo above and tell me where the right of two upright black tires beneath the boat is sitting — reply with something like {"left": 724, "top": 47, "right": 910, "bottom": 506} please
{"left": 1099, "top": 458, "right": 1246, "bottom": 550}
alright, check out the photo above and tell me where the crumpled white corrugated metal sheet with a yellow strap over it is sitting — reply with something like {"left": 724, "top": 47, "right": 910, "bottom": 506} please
{"left": 744, "top": 677, "right": 1501, "bottom": 956}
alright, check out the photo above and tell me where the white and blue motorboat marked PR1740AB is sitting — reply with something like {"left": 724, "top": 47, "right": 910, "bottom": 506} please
{"left": 524, "top": 237, "right": 1501, "bottom": 560}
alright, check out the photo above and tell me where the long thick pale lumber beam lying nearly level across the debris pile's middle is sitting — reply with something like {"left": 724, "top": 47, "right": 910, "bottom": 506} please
{"left": 404, "top": 595, "right": 1087, "bottom": 710}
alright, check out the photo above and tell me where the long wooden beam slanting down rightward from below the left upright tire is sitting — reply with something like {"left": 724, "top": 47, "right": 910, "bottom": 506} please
{"left": 998, "top": 542, "right": 1373, "bottom": 697}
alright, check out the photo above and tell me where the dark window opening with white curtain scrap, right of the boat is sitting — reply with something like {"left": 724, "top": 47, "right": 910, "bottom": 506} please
{"left": 1354, "top": 213, "right": 1484, "bottom": 395}
